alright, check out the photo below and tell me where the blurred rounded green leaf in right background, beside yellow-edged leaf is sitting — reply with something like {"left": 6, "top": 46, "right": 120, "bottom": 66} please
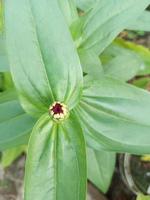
{"left": 104, "top": 48, "right": 143, "bottom": 81}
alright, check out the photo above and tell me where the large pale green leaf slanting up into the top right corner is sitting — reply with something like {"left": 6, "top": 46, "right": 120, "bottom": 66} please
{"left": 80, "top": 0, "right": 150, "bottom": 55}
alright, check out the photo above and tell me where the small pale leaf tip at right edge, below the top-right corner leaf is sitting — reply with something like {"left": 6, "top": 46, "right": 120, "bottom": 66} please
{"left": 127, "top": 11, "right": 150, "bottom": 31}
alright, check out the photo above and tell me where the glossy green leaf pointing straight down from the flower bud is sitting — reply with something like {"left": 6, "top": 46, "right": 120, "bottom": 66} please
{"left": 25, "top": 114, "right": 87, "bottom": 200}
